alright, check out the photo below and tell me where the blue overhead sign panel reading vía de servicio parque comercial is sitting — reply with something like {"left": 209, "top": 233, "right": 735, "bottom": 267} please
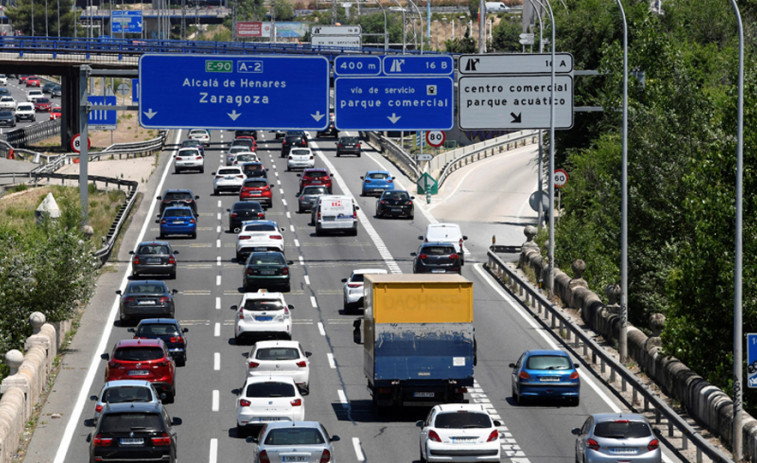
{"left": 334, "top": 76, "right": 455, "bottom": 131}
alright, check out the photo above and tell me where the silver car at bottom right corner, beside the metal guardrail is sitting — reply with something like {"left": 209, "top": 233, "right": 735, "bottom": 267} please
{"left": 572, "top": 413, "right": 662, "bottom": 463}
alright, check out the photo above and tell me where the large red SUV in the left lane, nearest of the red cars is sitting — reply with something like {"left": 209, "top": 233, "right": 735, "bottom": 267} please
{"left": 101, "top": 339, "right": 176, "bottom": 402}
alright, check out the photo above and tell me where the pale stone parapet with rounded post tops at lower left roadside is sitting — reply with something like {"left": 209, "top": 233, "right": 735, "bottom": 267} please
{"left": 0, "top": 312, "right": 66, "bottom": 463}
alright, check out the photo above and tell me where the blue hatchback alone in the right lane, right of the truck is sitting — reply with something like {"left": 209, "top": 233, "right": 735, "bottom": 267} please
{"left": 510, "top": 350, "right": 581, "bottom": 406}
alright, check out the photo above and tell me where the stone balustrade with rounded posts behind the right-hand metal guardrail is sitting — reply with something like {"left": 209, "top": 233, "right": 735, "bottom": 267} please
{"left": 519, "top": 246, "right": 757, "bottom": 461}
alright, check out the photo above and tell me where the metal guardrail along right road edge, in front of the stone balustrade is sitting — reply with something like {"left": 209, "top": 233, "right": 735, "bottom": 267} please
{"left": 486, "top": 250, "right": 733, "bottom": 462}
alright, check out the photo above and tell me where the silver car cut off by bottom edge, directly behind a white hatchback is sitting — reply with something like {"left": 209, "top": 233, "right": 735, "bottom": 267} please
{"left": 253, "top": 421, "right": 339, "bottom": 463}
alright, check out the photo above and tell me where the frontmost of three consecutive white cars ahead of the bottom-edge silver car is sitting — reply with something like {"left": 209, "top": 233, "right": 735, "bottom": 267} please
{"left": 231, "top": 289, "right": 294, "bottom": 343}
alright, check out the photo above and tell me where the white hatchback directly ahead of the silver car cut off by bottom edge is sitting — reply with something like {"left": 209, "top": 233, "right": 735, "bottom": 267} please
{"left": 237, "top": 376, "right": 305, "bottom": 434}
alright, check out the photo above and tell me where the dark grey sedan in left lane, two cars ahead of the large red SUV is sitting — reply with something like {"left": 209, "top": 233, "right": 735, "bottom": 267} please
{"left": 116, "top": 280, "right": 177, "bottom": 323}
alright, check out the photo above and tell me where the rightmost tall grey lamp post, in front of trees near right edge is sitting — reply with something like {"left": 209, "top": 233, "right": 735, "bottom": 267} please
{"left": 731, "top": 0, "right": 744, "bottom": 462}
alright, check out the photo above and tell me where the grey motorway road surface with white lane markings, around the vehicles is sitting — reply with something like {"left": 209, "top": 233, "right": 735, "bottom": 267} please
{"left": 27, "top": 131, "right": 678, "bottom": 463}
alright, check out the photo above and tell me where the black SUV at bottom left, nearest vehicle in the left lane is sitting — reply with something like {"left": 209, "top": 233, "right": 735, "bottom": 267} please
{"left": 89, "top": 402, "right": 181, "bottom": 463}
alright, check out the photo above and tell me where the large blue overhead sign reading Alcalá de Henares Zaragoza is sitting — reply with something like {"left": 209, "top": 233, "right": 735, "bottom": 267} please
{"left": 139, "top": 54, "right": 329, "bottom": 130}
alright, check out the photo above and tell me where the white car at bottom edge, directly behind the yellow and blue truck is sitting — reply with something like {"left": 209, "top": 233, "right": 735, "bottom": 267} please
{"left": 416, "top": 404, "right": 502, "bottom": 463}
